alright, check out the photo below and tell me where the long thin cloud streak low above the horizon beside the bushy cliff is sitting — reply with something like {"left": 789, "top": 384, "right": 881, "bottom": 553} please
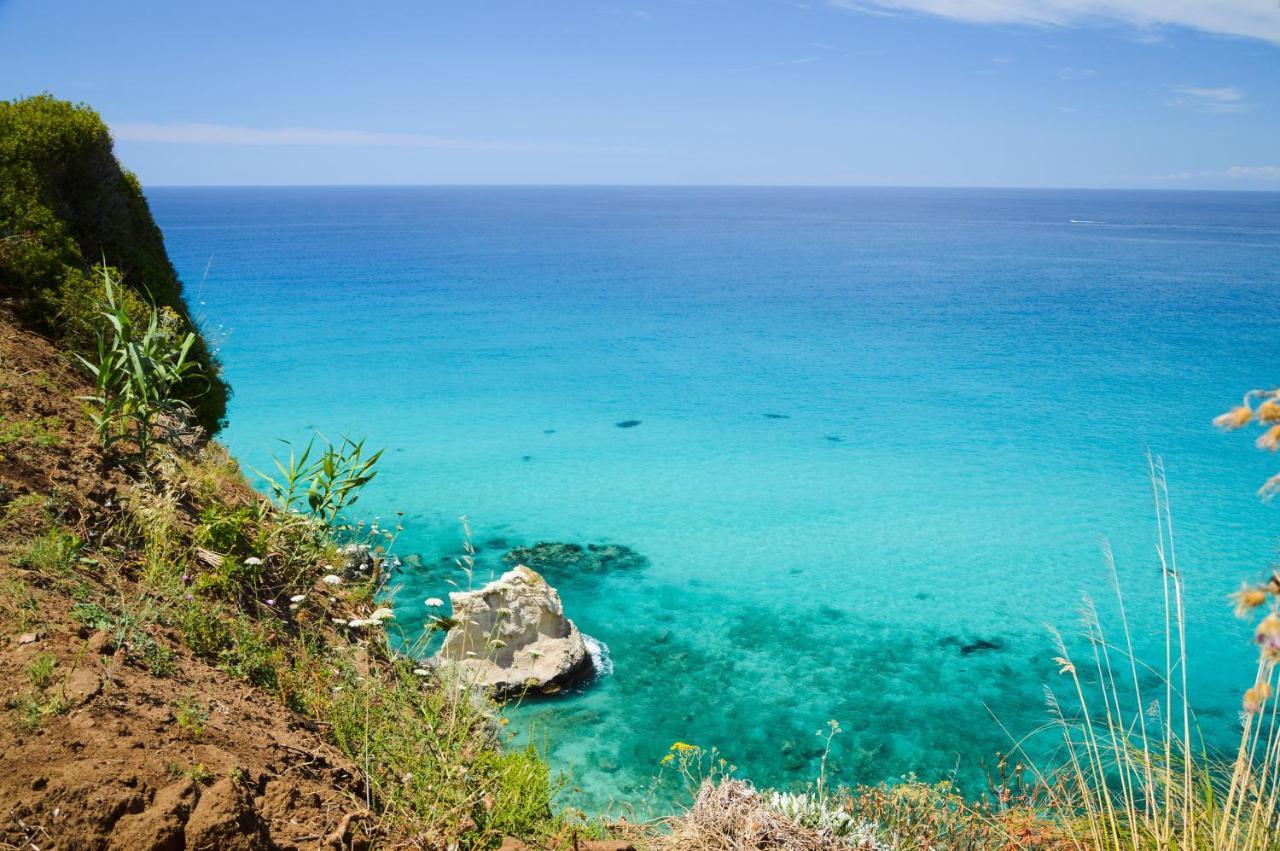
{"left": 111, "top": 123, "right": 652, "bottom": 152}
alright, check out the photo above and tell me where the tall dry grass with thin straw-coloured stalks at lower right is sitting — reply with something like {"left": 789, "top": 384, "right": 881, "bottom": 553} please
{"left": 1008, "top": 459, "right": 1280, "bottom": 851}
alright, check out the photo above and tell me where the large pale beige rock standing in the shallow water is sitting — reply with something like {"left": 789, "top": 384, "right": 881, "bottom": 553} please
{"left": 435, "top": 564, "right": 591, "bottom": 696}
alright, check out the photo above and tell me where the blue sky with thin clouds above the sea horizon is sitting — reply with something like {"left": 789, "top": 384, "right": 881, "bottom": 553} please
{"left": 0, "top": 0, "right": 1280, "bottom": 191}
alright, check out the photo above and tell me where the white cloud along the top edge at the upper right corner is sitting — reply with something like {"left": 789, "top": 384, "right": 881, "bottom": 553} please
{"left": 827, "top": 0, "right": 1280, "bottom": 44}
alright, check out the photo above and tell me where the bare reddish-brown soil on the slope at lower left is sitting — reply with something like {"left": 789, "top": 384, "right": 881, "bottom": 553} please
{"left": 0, "top": 312, "right": 366, "bottom": 851}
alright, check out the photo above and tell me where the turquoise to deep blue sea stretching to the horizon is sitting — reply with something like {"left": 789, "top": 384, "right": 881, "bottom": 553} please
{"left": 150, "top": 188, "right": 1280, "bottom": 807}
